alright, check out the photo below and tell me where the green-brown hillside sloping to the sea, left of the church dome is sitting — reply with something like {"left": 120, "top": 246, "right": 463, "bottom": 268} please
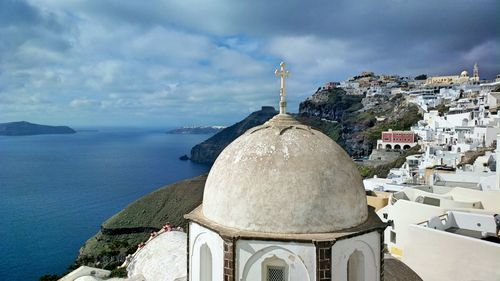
{"left": 72, "top": 175, "right": 207, "bottom": 269}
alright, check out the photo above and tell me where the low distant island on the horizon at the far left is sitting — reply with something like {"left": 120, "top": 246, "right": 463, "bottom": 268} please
{"left": 0, "top": 121, "right": 76, "bottom": 136}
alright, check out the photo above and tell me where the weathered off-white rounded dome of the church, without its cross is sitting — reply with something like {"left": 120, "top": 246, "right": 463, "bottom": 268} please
{"left": 202, "top": 114, "right": 368, "bottom": 233}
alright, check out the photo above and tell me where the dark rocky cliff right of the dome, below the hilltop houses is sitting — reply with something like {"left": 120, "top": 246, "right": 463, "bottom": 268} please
{"left": 298, "top": 89, "right": 421, "bottom": 157}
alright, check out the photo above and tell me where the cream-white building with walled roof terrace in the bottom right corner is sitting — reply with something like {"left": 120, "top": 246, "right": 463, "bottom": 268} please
{"left": 403, "top": 211, "right": 500, "bottom": 281}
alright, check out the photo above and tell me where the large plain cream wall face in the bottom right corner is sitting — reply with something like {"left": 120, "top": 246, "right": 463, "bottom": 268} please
{"left": 403, "top": 225, "right": 500, "bottom": 281}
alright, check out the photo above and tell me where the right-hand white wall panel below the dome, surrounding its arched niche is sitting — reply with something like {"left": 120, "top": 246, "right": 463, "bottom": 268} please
{"left": 332, "top": 231, "right": 380, "bottom": 281}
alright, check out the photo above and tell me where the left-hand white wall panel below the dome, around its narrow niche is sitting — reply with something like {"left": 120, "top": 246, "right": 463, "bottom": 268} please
{"left": 189, "top": 222, "right": 224, "bottom": 281}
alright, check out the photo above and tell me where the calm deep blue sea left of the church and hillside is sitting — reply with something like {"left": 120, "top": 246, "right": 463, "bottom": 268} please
{"left": 0, "top": 129, "right": 209, "bottom": 281}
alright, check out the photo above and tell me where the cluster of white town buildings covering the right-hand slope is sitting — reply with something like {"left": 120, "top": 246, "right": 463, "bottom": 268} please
{"left": 364, "top": 66, "right": 500, "bottom": 280}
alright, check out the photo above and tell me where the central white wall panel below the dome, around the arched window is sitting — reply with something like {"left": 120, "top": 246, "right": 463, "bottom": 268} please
{"left": 236, "top": 240, "right": 316, "bottom": 281}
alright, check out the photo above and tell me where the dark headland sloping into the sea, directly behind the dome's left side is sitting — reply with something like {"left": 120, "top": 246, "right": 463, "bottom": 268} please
{"left": 191, "top": 106, "right": 278, "bottom": 164}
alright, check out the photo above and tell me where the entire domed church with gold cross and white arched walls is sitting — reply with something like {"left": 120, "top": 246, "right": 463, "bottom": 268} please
{"left": 185, "top": 64, "right": 386, "bottom": 281}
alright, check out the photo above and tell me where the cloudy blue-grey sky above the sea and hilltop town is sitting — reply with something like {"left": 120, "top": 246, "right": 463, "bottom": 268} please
{"left": 0, "top": 0, "right": 500, "bottom": 127}
